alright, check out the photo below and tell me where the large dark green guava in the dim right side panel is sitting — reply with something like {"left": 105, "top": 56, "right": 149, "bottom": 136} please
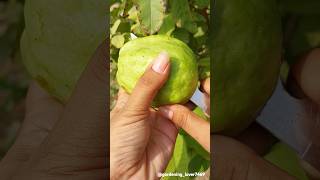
{"left": 210, "top": 0, "right": 282, "bottom": 135}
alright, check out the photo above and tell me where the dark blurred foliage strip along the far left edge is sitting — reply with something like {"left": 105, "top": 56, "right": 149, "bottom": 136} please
{"left": 0, "top": 0, "right": 30, "bottom": 158}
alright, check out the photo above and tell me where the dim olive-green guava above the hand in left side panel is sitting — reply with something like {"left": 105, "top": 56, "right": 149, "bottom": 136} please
{"left": 21, "top": 0, "right": 108, "bottom": 102}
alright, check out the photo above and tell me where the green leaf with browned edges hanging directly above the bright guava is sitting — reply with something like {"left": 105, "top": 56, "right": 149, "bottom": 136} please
{"left": 137, "top": 0, "right": 166, "bottom": 34}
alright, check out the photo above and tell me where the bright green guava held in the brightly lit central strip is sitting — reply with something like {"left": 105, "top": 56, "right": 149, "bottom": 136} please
{"left": 117, "top": 35, "right": 198, "bottom": 106}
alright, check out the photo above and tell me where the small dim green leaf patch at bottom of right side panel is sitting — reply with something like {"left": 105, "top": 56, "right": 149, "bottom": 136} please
{"left": 264, "top": 142, "right": 308, "bottom": 180}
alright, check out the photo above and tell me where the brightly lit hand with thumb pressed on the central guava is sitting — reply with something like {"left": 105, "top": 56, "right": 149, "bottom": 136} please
{"left": 110, "top": 54, "right": 178, "bottom": 179}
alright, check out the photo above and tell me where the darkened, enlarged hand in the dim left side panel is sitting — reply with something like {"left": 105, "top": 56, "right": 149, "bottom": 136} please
{"left": 0, "top": 41, "right": 109, "bottom": 180}
